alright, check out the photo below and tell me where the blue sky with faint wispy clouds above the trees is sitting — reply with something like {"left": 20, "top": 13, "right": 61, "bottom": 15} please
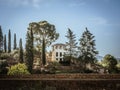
{"left": 0, "top": 0, "right": 120, "bottom": 57}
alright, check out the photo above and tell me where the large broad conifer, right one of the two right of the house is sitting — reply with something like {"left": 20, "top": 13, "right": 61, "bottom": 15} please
{"left": 79, "top": 28, "right": 98, "bottom": 68}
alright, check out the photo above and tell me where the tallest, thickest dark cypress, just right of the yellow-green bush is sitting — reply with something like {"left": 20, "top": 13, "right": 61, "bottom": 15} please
{"left": 25, "top": 26, "right": 34, "bottom": 73}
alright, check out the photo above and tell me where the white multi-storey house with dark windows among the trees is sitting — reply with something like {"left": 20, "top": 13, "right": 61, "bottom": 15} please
{"left": 52, "top": 43, "right": 66, "bottom": 61}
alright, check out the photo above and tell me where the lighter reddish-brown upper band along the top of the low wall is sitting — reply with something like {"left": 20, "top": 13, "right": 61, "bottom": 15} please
{"left": 0, "top": 74, "right": 120, "bottom": 80}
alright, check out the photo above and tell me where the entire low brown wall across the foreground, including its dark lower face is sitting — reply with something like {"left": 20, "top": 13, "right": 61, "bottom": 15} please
{"left": 0, "top": 74, "right": 120, "bottom": 90}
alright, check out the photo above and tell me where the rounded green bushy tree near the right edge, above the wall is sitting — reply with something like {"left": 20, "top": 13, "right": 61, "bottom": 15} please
{"left": 102, "top": 54, "right": 117, "bottom": 73}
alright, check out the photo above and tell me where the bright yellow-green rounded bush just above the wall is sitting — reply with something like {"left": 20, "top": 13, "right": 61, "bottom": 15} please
{"left": 8, "top": 63, "right": 30, "bottom": 75}
